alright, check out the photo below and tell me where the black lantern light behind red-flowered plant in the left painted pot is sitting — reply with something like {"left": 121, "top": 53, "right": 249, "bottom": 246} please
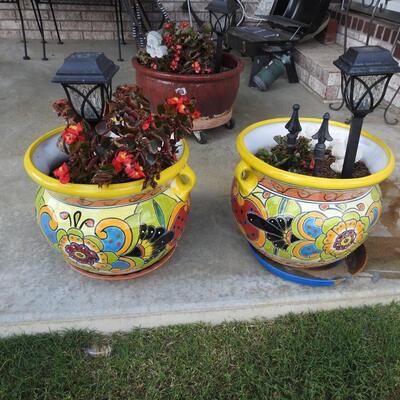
{"left": 52, "top": 52, "right": 119, "bottom": 123}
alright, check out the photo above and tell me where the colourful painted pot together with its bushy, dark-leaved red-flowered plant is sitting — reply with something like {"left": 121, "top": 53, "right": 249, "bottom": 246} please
{"left": 24, "top": 53, "right": 197, "bottom": 280}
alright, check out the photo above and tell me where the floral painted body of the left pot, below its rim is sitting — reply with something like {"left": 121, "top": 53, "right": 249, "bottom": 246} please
{"left": 36, "top": 185, "right": 190, "bottom": 275}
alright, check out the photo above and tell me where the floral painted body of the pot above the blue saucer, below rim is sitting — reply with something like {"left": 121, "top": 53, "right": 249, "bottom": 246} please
{"left": 232, "top": 180, "right": 382, "bottom": 268}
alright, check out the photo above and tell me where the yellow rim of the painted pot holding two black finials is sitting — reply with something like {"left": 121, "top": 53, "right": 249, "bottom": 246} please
{"left": 236, "top": 118, "right": 395, "bottom": 190}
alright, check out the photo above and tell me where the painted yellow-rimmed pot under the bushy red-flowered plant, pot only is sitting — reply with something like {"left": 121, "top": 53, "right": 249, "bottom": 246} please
{"left": 24, "top": 127, "right": 196, "bottom": 279}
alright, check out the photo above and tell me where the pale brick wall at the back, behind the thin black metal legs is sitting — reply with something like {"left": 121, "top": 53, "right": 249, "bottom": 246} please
{"left": 0, "top": 0, "right": 260, "bottom": 40}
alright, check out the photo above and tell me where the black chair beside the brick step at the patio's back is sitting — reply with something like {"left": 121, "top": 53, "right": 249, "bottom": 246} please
{"left": 228, "top": 0, "right": 330, "bottom": 86}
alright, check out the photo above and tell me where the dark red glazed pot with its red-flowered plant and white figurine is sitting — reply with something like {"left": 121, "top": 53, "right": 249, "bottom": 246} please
{"left": 132, "top": 22, "right": 243, "bottom": 142}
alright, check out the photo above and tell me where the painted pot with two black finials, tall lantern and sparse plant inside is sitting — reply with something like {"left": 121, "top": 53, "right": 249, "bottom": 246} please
{"left": 232, "top": 46, "right": 400, "bottom": 276}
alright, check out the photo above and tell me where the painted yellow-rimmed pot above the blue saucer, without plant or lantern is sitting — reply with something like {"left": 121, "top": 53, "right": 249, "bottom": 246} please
{"left": 232, "top": 118, "right": 395, "bottom": 268}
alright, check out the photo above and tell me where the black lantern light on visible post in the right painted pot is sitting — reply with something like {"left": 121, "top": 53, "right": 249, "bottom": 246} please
{"left": 334, "top": 46, "right": 400, "bottom": 178}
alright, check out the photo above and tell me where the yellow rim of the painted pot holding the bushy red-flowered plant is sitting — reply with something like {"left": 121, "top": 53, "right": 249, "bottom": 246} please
{"left": 24, "top": 126, "right": 189, "bottom": 199}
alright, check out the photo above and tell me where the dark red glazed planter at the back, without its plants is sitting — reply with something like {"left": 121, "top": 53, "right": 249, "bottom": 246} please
{"left": 132, "top": 53, "right": 243, "bottom": 130}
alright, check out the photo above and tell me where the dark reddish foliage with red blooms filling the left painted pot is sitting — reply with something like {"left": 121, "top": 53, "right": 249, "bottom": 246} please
{"left": 52, "top": 85, "right": 200, "bottom": 187}
